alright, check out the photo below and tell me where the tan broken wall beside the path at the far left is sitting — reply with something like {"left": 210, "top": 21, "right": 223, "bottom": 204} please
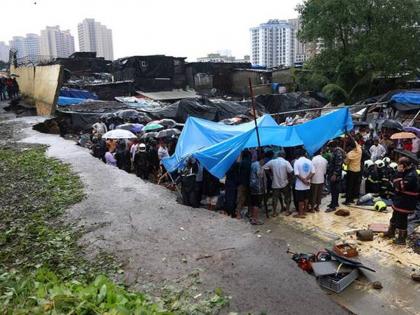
{"left": 10, "top": 65, "right": 63, "bottom": 116}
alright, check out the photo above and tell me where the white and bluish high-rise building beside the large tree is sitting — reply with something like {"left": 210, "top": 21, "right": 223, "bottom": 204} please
{"left": 250, "top": 19, "right": 307, "bottom": 68}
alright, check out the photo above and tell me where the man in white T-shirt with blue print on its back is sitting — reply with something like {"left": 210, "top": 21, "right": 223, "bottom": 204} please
{"left": 294, "top": 149, "right": 315, "bottom": 219}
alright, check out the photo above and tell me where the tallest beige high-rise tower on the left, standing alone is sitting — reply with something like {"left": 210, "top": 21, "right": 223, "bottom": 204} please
{"left": 77, "top": 19, "right": 114, "bottom": 60}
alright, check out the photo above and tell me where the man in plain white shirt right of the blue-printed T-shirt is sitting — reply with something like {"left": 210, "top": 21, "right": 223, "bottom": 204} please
{"left": 311, "top": 151, "right": 328, "bottom": 212}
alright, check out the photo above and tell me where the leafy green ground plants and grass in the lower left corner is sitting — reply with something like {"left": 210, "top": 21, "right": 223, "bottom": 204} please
{"left": 0, "top": 147, "right": 228, "bottom": 314}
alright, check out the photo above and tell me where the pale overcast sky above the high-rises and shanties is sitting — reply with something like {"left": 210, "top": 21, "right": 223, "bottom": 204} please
{"left": 0, "top": 0, "right": 302, "bottom": 60}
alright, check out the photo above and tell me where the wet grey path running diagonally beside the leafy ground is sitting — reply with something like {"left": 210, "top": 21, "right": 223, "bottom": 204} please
{"left": 0, "top": 103, "right": 348, "bottom": 314}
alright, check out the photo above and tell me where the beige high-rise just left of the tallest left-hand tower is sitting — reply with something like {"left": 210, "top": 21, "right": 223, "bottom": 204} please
{"left": 40, "top": 25, "right": 75, "bottom": 58}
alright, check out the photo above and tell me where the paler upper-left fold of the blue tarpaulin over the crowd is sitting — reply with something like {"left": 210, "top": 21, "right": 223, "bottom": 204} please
{"left": 163, "top": 115, "right": 278, "bottom": 172}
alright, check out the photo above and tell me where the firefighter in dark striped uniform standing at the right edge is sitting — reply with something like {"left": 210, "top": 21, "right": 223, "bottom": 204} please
{"left": 384, "top": 157, "right": 419, "bottom": 245}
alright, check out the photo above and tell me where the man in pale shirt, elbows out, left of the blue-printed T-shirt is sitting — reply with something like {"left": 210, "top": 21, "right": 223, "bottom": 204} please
{"left": 264, "top": 153, "right": 293, "bottom": 217}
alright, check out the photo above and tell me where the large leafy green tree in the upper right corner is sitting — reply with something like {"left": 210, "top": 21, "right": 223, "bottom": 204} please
{"left": 297, "top": 0, "right": 420, "bottom": 100}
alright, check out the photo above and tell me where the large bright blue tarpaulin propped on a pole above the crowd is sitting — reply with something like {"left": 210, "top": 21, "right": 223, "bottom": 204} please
{"left": 163, "top": 108, "right": 353, "bottom": 178}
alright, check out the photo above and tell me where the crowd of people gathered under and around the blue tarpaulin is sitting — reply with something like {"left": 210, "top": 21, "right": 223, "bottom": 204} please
{"left": 83, "top": 116, "right": 420, "bottom": 244}
